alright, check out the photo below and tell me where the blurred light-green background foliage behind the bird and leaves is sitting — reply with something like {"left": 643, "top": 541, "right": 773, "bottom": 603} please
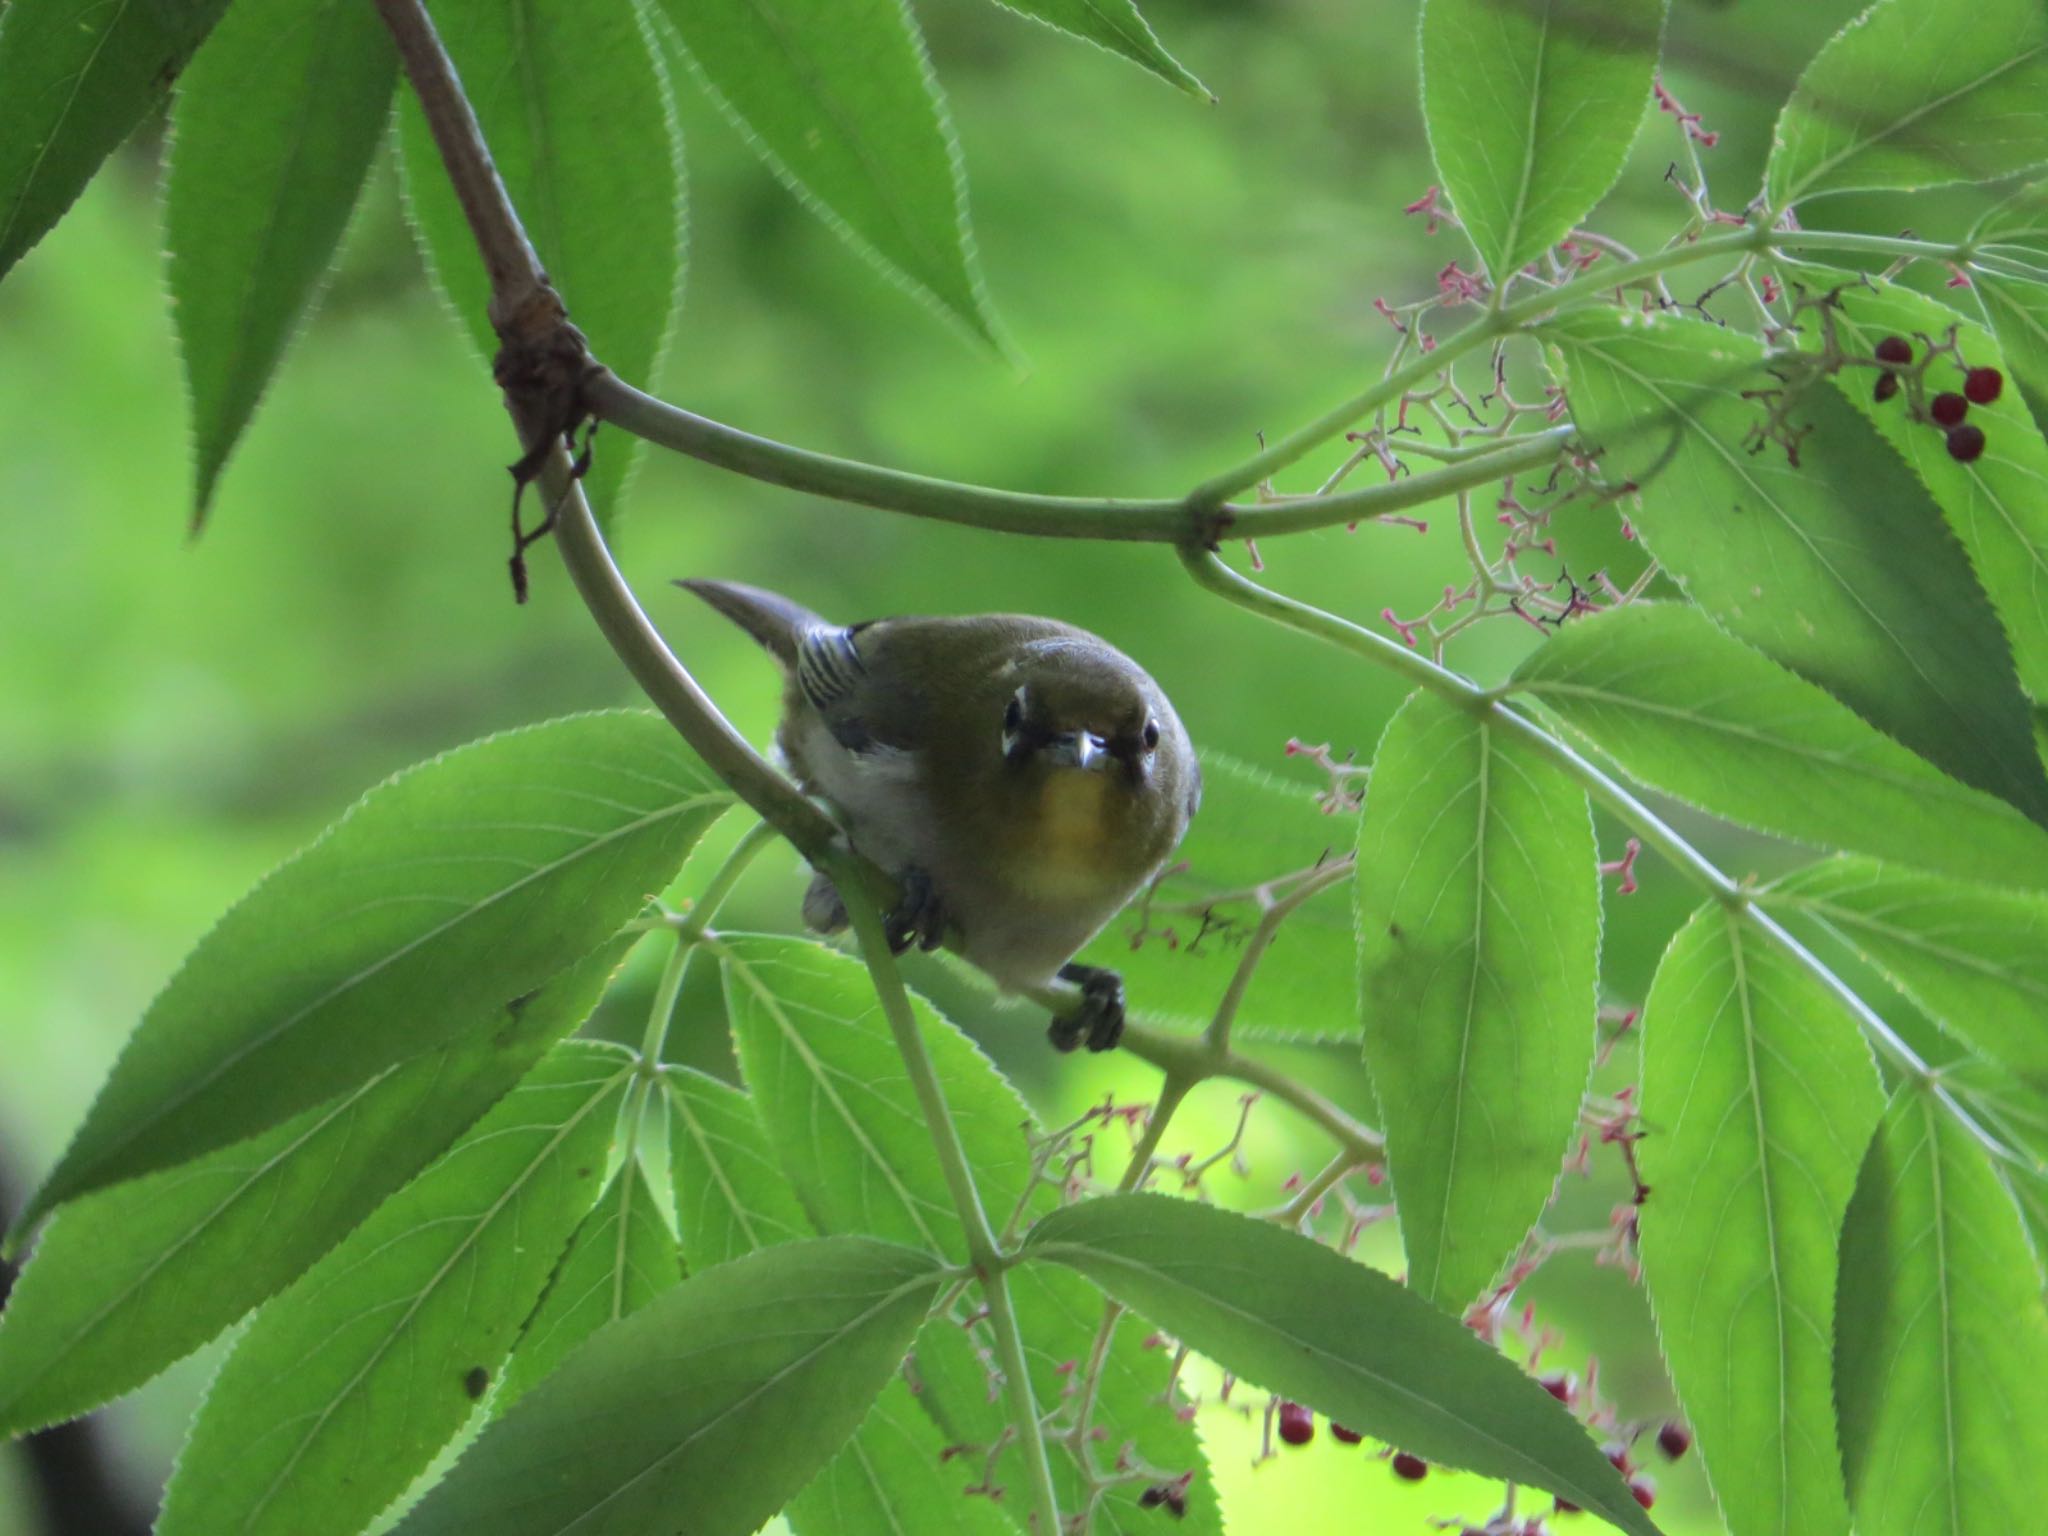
{"left": 0, "top": 0, "right": 1903, "bottom": 1536}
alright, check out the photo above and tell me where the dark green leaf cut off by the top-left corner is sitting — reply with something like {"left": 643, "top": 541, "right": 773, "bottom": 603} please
{"left": 0, "top": 0, "right": 227, "bottom": 276}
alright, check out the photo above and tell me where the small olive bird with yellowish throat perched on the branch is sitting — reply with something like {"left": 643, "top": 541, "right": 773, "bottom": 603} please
{"left": 676, "top": 582, "right": 1202, "bottom": 1051}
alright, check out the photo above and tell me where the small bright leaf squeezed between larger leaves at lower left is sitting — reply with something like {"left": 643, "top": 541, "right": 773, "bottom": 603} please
{"left": 492, "top": 1161, "right": 682, "bottom": 1413}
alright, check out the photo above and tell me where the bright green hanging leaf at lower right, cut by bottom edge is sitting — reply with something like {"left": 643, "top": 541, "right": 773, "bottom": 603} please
{"left": 1636, "top": 903, "right": 1884, "bottom": 1536}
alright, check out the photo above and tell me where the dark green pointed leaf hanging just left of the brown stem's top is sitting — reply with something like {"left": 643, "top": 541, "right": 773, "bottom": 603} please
{"left": 164, "top": 0, "right": 397, "bottom": 526}
